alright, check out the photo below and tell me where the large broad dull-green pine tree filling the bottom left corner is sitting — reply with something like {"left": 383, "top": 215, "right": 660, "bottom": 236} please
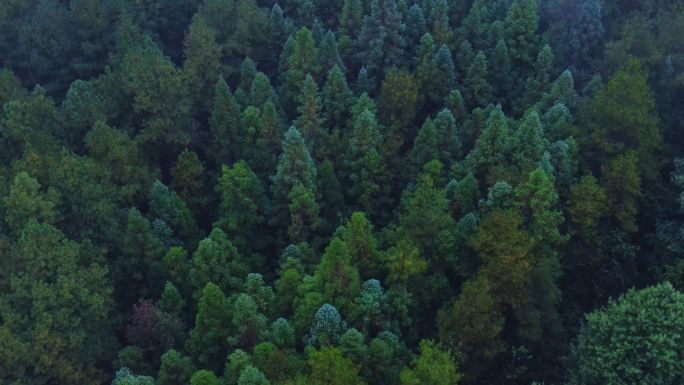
{"left": 0, "top": 219, "right": 115, "bottom": 385}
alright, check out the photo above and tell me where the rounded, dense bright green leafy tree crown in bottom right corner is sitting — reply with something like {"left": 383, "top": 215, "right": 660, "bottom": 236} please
{"left": 572, "top": 283, "right": 684, "bottom": 384}
